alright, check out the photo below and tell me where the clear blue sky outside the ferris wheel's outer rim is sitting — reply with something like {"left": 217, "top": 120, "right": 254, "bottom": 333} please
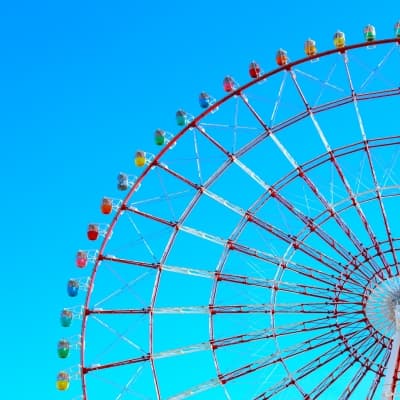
{"left": 0, "top": 0, "right": 400, "bottom": 400}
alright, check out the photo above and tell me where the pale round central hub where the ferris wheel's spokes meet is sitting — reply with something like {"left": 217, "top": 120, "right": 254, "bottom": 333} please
{"left": 365, "top": 276, "right": 400, "bottom": 338}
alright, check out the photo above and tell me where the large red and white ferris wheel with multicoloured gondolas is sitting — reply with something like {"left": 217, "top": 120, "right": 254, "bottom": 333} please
{"left": 57, "top": 23, "right": 400, "bottom": 400}
